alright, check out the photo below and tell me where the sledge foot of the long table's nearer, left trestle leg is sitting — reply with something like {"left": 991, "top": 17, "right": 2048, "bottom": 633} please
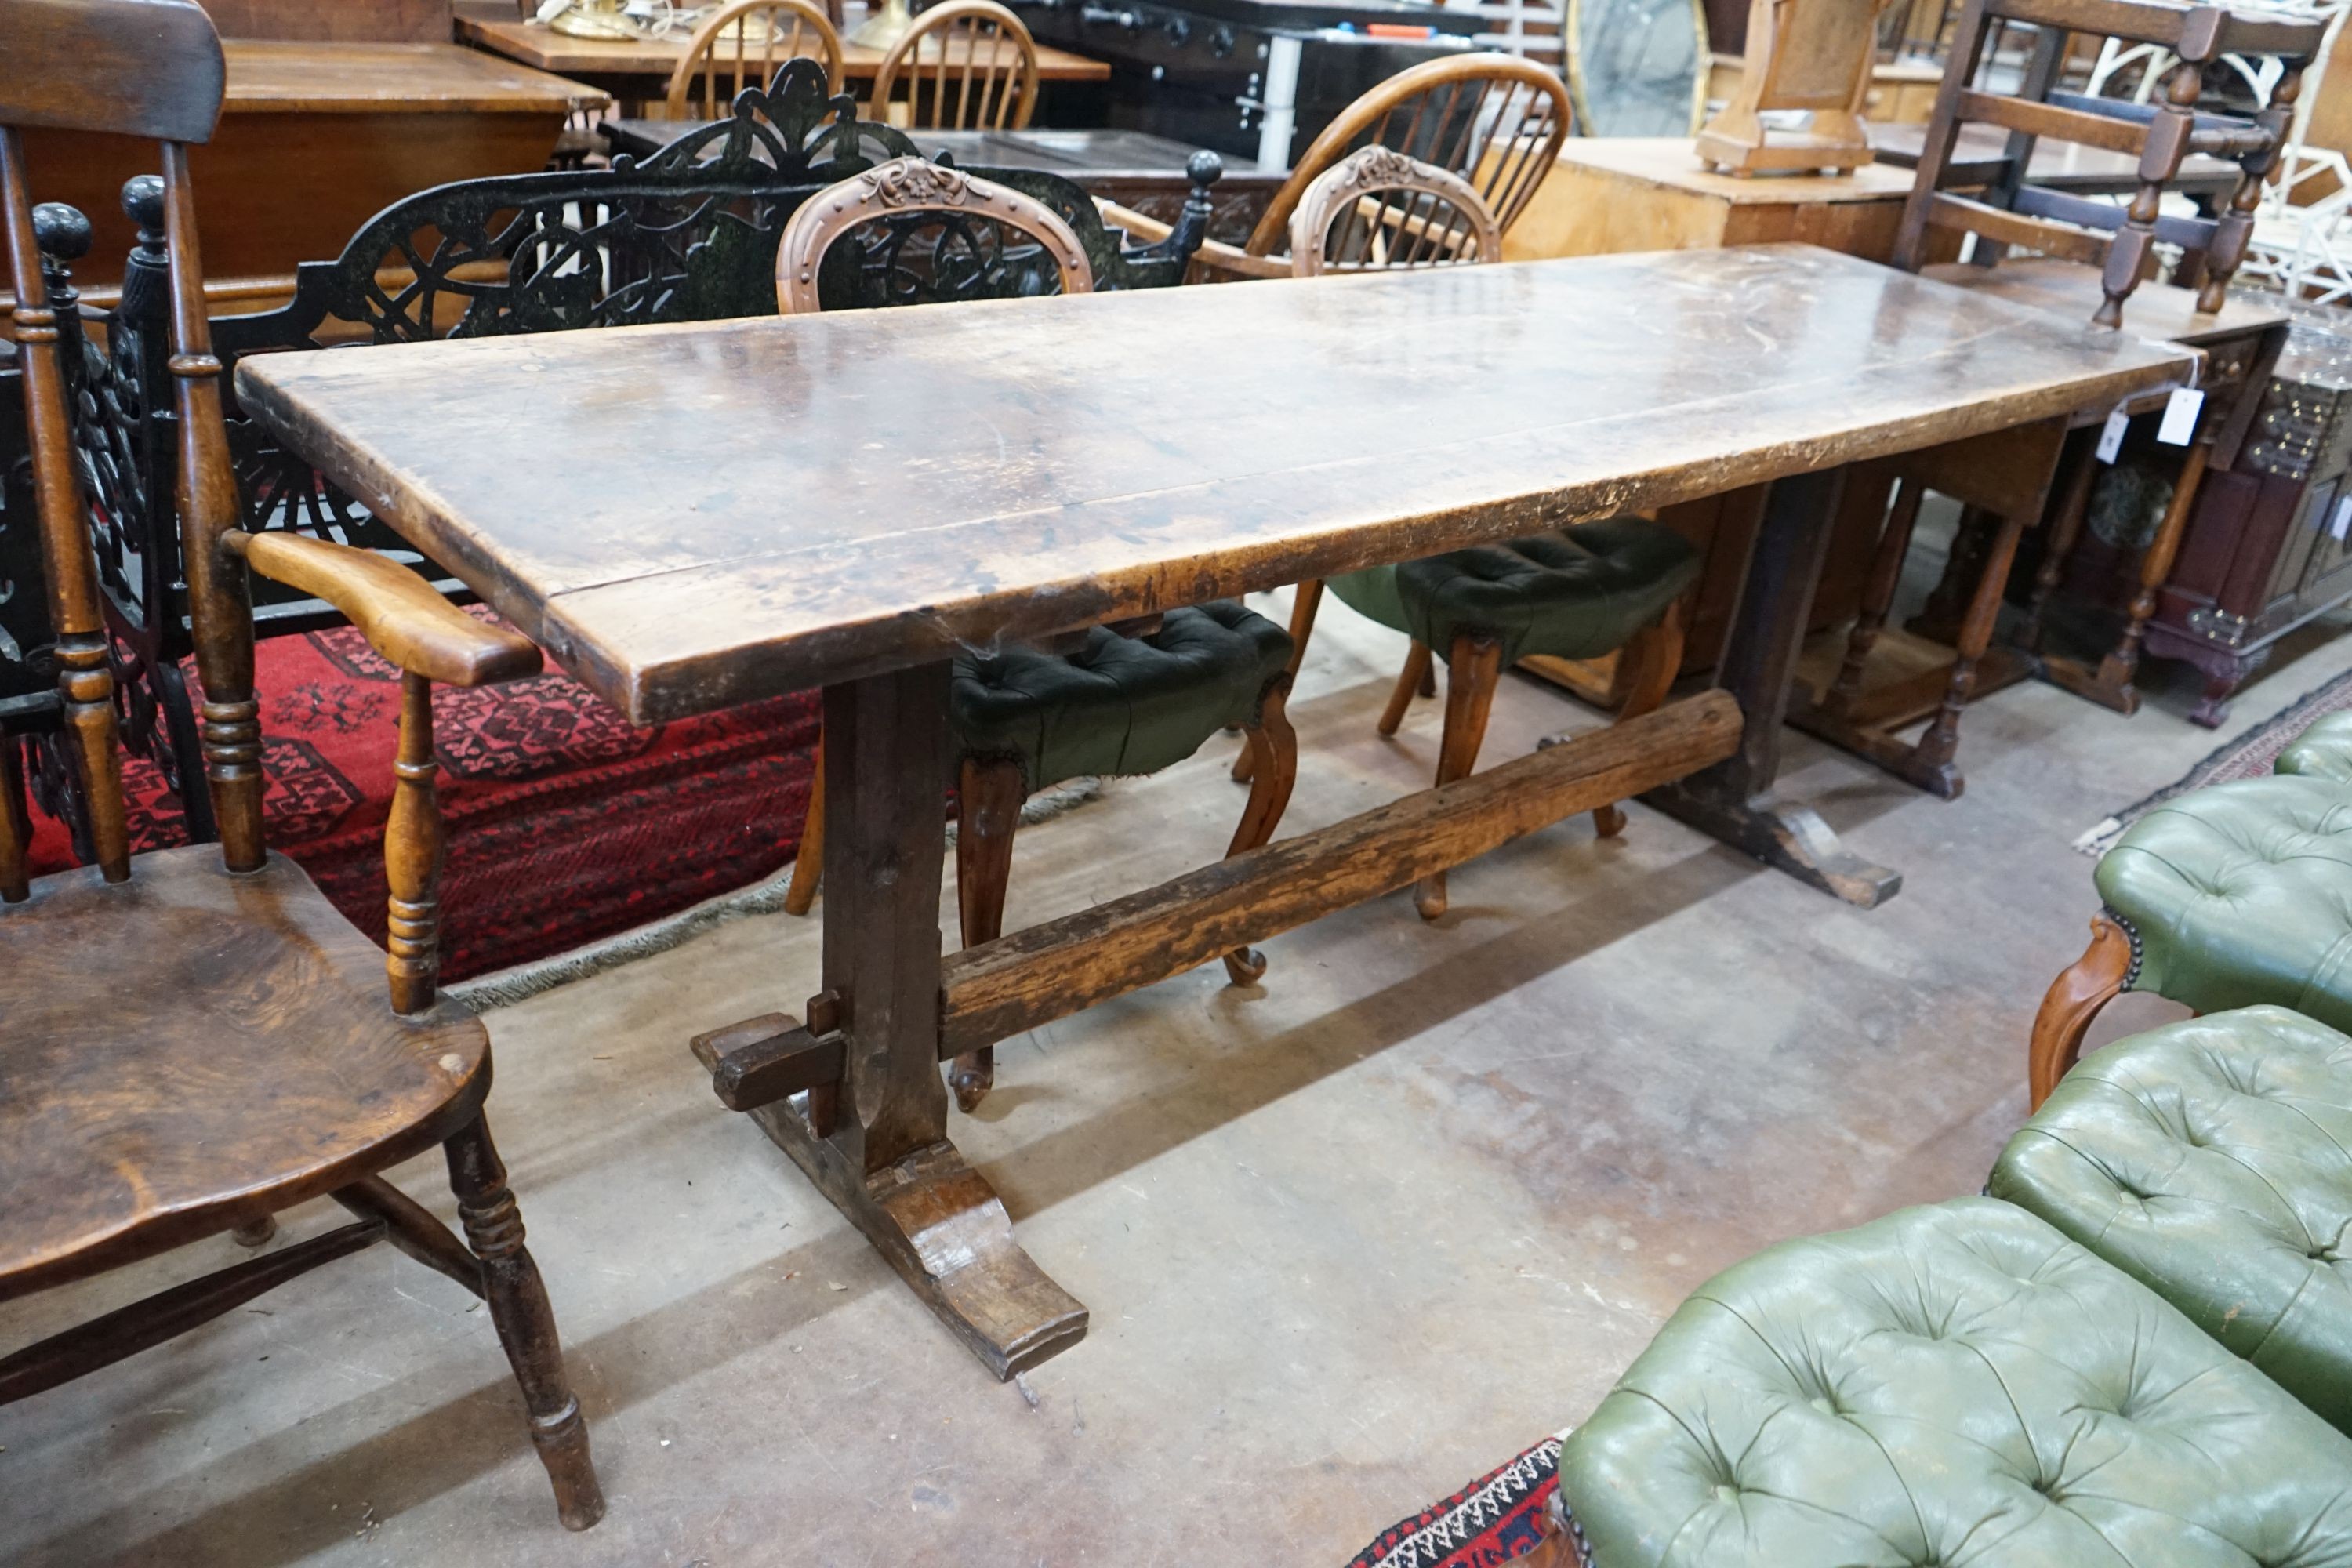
{"left": 746, "top": 1100, "right": 1087, "bottom": 1382}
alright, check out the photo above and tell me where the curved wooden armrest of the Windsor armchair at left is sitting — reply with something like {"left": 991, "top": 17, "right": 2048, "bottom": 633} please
{"left": 221, "top": 529, "right": 541, "bottom": 687}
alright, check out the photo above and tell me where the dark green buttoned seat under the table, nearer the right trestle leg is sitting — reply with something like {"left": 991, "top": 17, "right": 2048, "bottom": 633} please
{"left": 1329, "top": 517, "right": 1700, "bottom": 666}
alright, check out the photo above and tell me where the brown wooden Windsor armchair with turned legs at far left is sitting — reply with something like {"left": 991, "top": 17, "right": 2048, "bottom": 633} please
{"left": 0, "top": 0, "right": 604, "bottom": 1530}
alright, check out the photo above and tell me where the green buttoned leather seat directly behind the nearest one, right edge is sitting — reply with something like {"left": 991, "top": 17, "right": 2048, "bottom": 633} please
{"left": 1992, "top": 1006, "right": 2352, "bottom": 1432}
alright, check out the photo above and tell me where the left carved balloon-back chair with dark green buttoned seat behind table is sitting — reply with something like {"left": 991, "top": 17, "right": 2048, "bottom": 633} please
{"left": 776, "top": 155, "right": 1298, "bottom": 1112}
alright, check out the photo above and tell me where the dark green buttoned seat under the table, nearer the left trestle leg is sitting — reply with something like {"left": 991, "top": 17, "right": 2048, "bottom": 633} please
{"left": 948, "top": 600, "right": 1291, "bottom": 789}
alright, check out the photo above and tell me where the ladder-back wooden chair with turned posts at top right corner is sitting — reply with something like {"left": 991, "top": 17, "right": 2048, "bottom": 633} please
{"left": 1893, "top": 0, "right": 2326, "bottom": 327}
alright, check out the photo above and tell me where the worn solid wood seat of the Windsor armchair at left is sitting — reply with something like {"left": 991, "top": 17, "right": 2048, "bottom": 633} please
{"left": 0, "top": 844, "right": 489, "bottom": 1298}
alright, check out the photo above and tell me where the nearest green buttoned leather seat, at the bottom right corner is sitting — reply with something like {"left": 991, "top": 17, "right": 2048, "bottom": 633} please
{"left": 1559, "top": 1199, "right": 2352, "bottom": 1568}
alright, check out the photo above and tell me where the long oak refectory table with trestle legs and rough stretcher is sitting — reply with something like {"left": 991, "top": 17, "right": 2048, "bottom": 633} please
{"left": 238, "top": 247, "right": 2192, "bottom": 1377}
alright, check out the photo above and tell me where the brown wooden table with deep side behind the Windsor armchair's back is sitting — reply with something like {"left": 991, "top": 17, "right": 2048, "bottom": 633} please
{"left": 24, "top": 38, "right": 609, "bottom": 301}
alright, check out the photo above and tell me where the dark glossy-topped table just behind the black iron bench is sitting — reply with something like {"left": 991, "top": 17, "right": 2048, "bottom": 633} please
{"left": 597, "top": 120, "right": 1289, "bottom": 245}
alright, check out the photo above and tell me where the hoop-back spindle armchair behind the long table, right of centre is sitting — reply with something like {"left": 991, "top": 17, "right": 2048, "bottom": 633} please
{"left": 1105, "top": 52, "right": 1571, "bottom": 278}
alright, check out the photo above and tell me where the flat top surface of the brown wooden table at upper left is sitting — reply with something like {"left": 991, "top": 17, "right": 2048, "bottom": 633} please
{"left": 221, "top": 38, "right": 612, "bottom": 115}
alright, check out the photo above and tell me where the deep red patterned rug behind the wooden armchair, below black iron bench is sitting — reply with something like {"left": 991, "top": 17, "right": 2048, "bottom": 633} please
{"left": 33, "top": 628, "right": 818, "bottom": 980}
